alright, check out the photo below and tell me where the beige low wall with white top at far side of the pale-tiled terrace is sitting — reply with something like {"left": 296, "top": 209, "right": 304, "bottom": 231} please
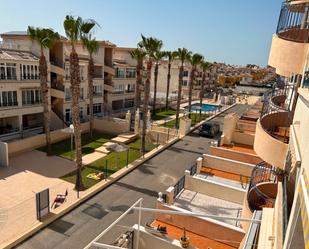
{"left": 185, "top": 175, "right": 246, "bottom": 205}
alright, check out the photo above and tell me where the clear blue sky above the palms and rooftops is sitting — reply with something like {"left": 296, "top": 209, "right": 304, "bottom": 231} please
{"left": 0, "top": 0, "right": 282, "bottom": 65}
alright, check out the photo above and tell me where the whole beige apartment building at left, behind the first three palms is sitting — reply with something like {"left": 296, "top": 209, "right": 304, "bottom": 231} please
{"left": 0, "top": 32, "right": 115, "bottom": 141}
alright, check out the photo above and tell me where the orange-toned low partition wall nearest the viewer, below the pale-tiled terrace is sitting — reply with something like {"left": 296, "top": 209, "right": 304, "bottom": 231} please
{"left": 156, "top": 202, "right": 245, "bottom": 247}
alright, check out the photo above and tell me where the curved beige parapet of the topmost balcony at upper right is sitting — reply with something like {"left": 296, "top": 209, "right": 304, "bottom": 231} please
{"left": 268, "top": 34, "right": 308, "bottom": 76}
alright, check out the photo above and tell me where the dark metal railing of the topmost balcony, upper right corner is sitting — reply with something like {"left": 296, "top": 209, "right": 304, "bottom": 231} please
{"left": 276, "top": 2, "right": 309, "bottom": 43}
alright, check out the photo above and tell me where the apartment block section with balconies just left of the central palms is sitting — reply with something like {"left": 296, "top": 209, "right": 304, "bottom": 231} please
{"left": 107, "top": 47, "right": 137, "bottom": 112}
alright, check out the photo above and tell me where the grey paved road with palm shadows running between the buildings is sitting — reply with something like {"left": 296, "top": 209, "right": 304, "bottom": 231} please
{"left": 16, "top": 105, "right": 247, "bottom": 249}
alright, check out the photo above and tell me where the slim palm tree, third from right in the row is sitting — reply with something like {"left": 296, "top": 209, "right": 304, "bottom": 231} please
{"left": 175, "top": 48, "right": 191, "bottom": 128}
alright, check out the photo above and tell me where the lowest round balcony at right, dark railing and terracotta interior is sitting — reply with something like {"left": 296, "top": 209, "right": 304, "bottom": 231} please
{"left": 247, "top": 162, "right": 278, "bottom": 212}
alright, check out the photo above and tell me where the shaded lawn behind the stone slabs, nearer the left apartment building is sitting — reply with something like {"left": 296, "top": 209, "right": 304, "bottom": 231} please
{"left": 38, "top": 132, "right": 114, "bottom": 160}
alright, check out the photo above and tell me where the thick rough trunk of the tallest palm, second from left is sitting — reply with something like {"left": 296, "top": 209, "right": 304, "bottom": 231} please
{"left": 70, "top": 46, "right": 84, "bottom": 191}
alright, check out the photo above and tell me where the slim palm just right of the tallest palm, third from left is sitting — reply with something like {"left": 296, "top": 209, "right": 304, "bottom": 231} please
{"left": 82, "top": 34, "right": 99, "bottom": 138}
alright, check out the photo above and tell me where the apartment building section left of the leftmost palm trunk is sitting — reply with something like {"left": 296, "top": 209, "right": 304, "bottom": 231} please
{"left": 0, "top": 32, "right": 45, "bottom": 139}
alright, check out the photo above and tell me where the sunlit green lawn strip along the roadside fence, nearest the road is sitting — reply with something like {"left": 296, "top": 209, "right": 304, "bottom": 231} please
{"left": 61, "top": 139, "right": 156, "bottom": 188}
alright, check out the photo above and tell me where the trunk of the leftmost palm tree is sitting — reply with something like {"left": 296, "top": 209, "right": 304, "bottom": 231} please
{"left": 39, "top": 50, "right": 52, "bottom": 156}
